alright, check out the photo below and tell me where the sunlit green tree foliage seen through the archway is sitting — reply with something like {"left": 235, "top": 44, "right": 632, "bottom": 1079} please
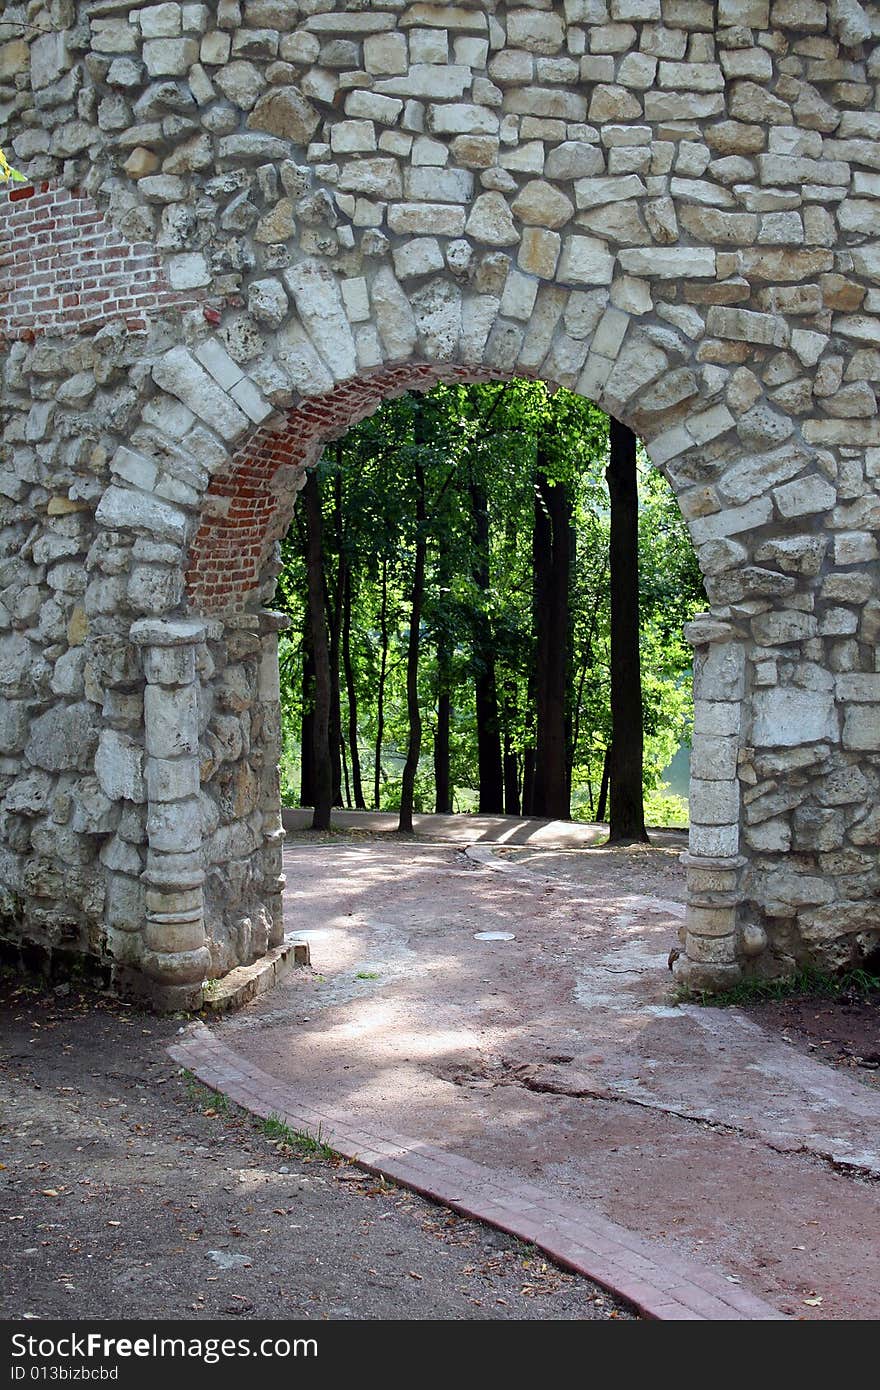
{"left": 277, "top": 379, "right": 705, "bottom": 819}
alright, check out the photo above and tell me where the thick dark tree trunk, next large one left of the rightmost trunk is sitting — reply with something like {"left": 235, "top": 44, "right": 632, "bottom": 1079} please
{"left": 532, "top": 450, "right": 571, "bottom": 819}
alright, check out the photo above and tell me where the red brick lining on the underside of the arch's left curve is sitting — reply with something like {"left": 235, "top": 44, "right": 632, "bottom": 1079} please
{"left": 186, "top": 364, "right": 503, "bottom": 614}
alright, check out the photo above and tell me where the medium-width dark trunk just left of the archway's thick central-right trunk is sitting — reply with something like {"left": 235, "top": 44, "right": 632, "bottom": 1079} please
{"left": 470, "top": 482, "right": 505, "bottom": 815}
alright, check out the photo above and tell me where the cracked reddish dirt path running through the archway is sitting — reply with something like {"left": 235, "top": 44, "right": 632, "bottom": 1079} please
{"left": 207, "top": 840, "right": 880, "bottom": 1318}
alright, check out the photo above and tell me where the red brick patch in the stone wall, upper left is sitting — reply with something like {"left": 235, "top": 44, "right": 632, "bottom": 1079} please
{"left": 0, "top": 183, "right": 197, "bottom": 342}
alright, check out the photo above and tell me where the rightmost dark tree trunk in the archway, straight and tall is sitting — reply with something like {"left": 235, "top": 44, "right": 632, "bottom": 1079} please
{"left": 606, "top": 420, "right": 648, "bottom": 844}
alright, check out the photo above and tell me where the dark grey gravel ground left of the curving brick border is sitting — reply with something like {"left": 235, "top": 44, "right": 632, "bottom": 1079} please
{"left": 0, "top": 977, "right": 631, "bottom": 1321}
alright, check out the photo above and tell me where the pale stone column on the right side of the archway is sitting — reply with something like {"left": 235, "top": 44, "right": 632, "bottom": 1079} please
{"left": 674, "top": 613, "right": 747, "bottom": 990}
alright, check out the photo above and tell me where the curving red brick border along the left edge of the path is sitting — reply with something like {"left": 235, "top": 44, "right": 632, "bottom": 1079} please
{"left": 168, "top": 1023, "right": 788, "bottom": 1322}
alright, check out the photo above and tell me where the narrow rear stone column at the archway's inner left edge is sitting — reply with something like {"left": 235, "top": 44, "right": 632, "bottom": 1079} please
{"left": 257, "top": 609, "right": 291, "bottom": 947}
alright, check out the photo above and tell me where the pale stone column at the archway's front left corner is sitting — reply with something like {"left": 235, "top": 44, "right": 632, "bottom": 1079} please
{"left": 131, "top": 619, "right": 211, "bottom": 1008}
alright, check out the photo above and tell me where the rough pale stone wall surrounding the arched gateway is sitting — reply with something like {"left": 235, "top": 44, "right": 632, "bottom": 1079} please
{"left": 0, "top": 0, "right": 880, "bottom": 1005}
